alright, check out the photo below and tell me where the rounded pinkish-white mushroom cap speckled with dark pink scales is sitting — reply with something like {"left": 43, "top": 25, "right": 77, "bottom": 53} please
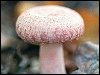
{"left": 16, "top": 5, "right": 84, "bottom": 43}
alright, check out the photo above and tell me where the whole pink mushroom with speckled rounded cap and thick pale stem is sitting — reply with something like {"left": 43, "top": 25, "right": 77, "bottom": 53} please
{"left": 16, "top": 5, "right": 84, "bottom": 74}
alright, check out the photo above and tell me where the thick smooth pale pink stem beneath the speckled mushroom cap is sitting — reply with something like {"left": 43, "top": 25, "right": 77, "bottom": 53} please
{"left": 40, "top": 43, "right": 66, "bottom": 74}
